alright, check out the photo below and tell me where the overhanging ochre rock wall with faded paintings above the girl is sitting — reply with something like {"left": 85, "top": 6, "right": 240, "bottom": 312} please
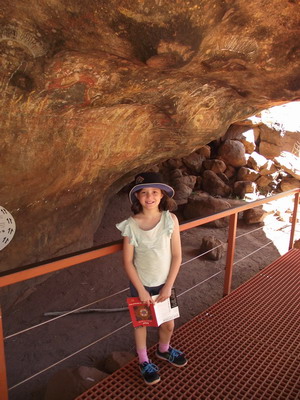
{"left": 0, "top": 0, "right": 300, "bottom": 270}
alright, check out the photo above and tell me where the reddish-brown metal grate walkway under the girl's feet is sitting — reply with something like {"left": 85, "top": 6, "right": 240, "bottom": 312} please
{"left": 77, "top": 249, "right": 300, "bottom": 400}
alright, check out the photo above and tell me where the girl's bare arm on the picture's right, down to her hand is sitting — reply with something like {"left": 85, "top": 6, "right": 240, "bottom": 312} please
{"left": 156, "top": 214, "right": 182, "bottom": 303}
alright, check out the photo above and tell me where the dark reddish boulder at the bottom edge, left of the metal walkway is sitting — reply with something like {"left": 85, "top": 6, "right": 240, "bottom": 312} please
{"left": 44, "top": 366, "right": 108, "bottom": 400}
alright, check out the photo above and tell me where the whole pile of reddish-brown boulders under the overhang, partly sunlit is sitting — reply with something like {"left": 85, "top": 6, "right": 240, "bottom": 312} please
{"left": 158, "top": 125, "right": 300, "bottom": 227}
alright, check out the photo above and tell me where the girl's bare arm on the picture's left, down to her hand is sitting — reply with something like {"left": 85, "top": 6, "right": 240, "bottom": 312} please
{"left": 123, "top": 236, "right": 153, "bottom": 305}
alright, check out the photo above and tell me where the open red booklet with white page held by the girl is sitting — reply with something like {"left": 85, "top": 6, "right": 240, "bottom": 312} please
{"left": 127, "top": 288, "right": 180, "bottom": 327}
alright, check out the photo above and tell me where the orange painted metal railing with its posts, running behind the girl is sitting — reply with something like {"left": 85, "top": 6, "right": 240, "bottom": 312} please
{"left": 0, "top": 189, "right": 300, "bottom": 400}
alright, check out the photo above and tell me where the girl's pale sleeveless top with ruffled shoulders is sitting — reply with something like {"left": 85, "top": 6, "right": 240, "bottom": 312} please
{"left": 116, "top": 211, "right": 174, "bottom": 287}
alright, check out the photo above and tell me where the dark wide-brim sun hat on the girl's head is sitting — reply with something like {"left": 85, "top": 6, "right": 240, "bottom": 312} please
{"left": 129, "top": 172, "right": 175, "bottom": 204}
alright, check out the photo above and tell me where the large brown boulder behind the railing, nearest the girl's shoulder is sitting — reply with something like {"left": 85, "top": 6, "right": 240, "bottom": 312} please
{"left": 183, "top": 192, "right": 231, "bottom": 228}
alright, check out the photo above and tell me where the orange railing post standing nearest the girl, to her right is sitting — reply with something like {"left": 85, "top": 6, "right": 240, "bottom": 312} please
{"left": 223, "top": 213, "right": 238, "bottom": 296}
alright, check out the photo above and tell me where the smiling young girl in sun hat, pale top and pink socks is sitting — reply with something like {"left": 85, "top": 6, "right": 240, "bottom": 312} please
{"left": 116, "top": 172, "right": 187, "bottom": 385}
